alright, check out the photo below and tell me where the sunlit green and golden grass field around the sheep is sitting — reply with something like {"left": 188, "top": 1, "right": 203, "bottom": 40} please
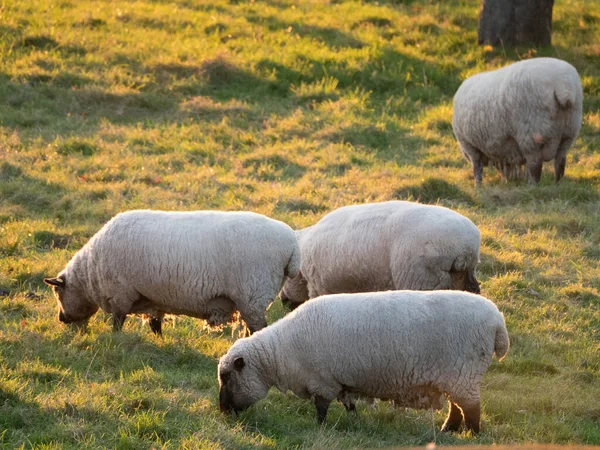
{"left": 0, "top": 0, "right": 600, "bottom": 449}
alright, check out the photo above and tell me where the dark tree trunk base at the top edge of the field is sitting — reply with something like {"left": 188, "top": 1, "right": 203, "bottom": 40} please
{"left": 479, "top": 0, "right": 554, "bottom": 46}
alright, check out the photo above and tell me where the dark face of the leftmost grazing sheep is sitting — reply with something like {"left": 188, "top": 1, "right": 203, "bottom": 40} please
{"left": 44, "top": 274, "right": 98, "bottom": 323}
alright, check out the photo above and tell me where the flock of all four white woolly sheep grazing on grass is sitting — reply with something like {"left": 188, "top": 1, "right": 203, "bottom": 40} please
{"left": 44, "top": 58, "right": 583, "bottom": 440}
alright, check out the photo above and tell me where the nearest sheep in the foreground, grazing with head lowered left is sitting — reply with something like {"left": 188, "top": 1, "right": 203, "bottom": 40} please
{"left": 218, "top": 291, "right": 509, "bottom": 433}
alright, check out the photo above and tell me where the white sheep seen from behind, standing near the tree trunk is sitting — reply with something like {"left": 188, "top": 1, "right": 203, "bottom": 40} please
{"left": 452, "top": 58, "right": 583, "bottom": 186}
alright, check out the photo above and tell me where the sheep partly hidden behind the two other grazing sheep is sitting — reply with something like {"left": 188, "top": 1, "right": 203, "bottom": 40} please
{"left": 281, "top": 201, "right": 481, "bottom": 309}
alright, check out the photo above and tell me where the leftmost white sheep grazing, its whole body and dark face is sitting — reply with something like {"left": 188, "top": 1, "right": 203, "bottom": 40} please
{"left": 44, "top": 210, "right": 300, "bottom": 334}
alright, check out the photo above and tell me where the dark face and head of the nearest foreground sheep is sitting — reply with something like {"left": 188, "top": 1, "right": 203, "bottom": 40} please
{"left": 219, "top": 353, "right": 269, "bottom": 413}
